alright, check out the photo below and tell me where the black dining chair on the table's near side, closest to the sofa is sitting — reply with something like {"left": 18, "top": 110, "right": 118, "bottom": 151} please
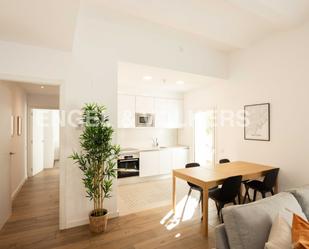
{"left": 209, "top": 176, "right": 242, "bottom": 222}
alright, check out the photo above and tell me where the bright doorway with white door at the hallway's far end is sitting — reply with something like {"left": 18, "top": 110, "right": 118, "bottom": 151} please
{"left": 28, "top": 109, "right": 60, "bottom": 176}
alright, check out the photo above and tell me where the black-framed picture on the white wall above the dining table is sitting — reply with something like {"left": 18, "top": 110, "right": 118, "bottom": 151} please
{"left": 244, "top": 103, "right": 270, "bottom": 141}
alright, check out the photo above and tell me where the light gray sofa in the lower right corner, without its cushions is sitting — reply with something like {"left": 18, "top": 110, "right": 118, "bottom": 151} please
{"left": 216, "top": 185, "right": 309, "bottom": 249}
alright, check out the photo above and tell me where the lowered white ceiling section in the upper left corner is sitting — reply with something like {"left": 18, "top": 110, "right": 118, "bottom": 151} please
{"left": 0, "top": 0, "right": 80, "bottom": 50}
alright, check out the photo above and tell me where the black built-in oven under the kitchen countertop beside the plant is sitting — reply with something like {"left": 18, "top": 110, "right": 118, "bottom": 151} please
{"left": 118, "top": 154, "right": 139, "bottom": 178}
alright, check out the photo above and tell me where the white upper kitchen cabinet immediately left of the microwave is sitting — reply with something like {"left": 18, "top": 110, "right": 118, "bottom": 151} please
{"left": 118, "top": 94, "right": 135, "bottom": 128}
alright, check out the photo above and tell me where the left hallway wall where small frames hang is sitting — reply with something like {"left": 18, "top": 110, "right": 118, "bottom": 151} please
{"left": 9, "top": 83, "right": 27, "bottom": 199}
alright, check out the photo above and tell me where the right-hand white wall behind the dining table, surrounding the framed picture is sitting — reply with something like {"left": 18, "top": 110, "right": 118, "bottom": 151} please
{"left": 182, "top": 20, "right": 309, "bottom": 190}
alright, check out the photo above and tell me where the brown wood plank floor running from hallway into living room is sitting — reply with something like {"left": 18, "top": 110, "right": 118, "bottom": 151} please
{"left": 0, "top": 168, "right": 217, "bottom": 249}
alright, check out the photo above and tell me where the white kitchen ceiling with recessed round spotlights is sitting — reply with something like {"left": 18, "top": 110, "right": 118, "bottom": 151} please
{"left": 118, "top": 62, "right": 224, "bottom": 93}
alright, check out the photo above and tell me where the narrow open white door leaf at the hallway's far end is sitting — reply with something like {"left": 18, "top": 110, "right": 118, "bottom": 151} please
{"left": 31, "top": 109, "right": 44, "bottom": 175}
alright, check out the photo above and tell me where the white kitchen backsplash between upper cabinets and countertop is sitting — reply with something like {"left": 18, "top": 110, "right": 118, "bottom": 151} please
{"left": 117, "top": 128, "right": 178, "bottom": 148}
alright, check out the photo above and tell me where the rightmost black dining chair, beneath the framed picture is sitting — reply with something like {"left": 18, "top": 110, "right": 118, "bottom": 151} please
{"left": 243, "top": 169, "right": 279, "bottom": 203}
